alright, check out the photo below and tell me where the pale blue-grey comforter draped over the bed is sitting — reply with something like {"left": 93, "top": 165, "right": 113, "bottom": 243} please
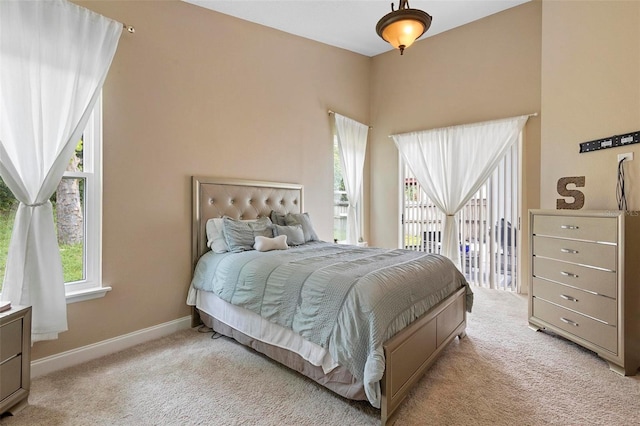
{"left": 191, "top": 242, "right": 473, "bottom": 408}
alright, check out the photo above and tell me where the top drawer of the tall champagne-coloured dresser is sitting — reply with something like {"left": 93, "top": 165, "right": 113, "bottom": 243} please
{"left": 533, "top": 215, "right": 618, "bottom": 243}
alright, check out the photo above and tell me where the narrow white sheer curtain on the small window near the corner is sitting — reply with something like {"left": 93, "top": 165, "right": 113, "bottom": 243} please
{"left": 333, "top": 113, "right": 369, "bottom": 244}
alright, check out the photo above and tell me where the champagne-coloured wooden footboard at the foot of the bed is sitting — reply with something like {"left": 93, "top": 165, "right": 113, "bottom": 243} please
{"left": 380, "top": 288, "right": 467, "bottom": 426}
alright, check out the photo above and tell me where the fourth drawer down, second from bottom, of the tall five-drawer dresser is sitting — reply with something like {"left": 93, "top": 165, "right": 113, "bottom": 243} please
{"left": 532, "top": 278, "right": 618, "bottom": 325}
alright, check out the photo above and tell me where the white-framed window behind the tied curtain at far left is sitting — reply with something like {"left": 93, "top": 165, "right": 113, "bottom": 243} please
{"left": 0, "top": 98, "right": 110, "bottom": 303}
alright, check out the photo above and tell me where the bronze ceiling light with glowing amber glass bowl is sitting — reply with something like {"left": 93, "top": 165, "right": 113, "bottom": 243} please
{"left": 376, "top": 0, "right": 431, "bottom": 55}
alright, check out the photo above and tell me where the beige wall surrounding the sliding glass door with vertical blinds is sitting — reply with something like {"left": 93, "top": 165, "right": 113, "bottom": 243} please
{"left": 369, "top": 2, "right": 541, "bottom": 290}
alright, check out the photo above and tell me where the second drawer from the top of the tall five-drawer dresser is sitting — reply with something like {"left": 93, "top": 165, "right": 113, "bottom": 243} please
{"left": 533, "top": 236, "right": 617, "bottom": 271}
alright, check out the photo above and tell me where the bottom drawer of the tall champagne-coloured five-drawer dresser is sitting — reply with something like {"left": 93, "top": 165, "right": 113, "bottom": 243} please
{"left": 533, "top": 297, "right": 618, "bottom": 354}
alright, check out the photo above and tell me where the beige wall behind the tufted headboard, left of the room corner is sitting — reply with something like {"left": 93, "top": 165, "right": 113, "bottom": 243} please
{"left": 33, "top": 1, "right": 371, "bottom": 359}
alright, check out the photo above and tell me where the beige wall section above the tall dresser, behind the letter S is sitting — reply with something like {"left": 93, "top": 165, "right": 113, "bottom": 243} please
{"left": 541, "top": 1, "right": 640, "bottom": 210}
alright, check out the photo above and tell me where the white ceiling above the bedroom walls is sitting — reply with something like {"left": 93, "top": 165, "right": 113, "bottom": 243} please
{"left": 183, "top": 0, "right": 531, "bottom": 56}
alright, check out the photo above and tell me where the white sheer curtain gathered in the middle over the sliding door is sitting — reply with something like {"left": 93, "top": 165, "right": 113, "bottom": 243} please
{"left": 392, "top": 115, "right": 529, "bottom": 268}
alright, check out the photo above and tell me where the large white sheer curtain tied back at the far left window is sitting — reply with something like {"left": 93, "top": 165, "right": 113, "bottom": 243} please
{"left": 0, "top": 0, "right": 122, "bottom": 341}
